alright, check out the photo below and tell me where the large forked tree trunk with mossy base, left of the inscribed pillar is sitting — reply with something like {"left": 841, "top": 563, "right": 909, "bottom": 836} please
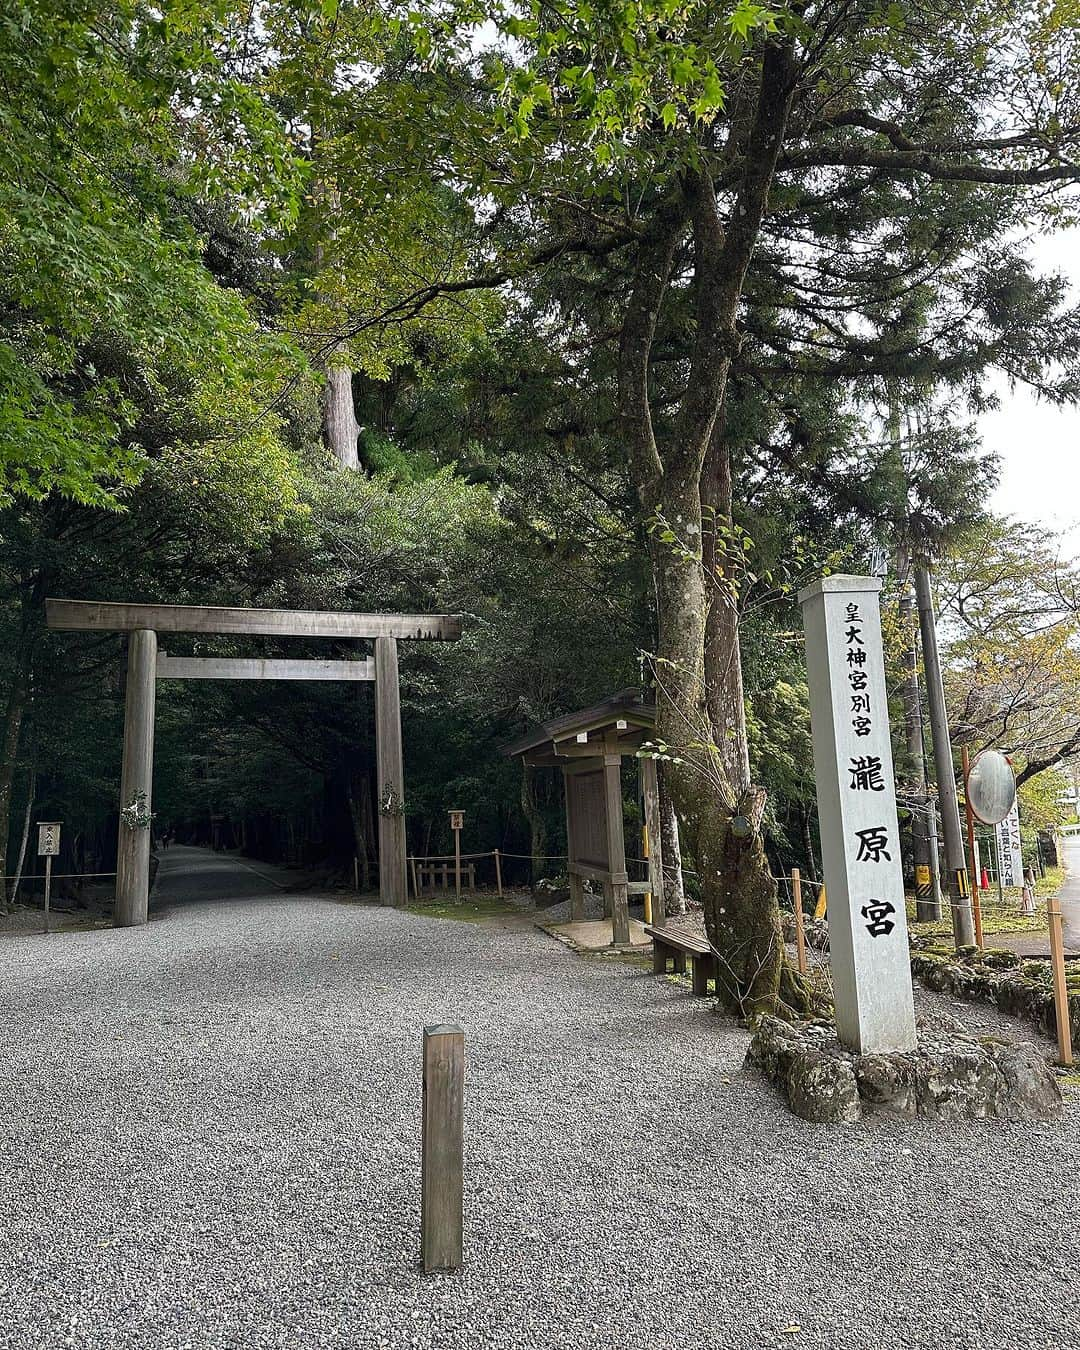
{"left": 618, "top": 39, "right": 797, "bottom": 1017}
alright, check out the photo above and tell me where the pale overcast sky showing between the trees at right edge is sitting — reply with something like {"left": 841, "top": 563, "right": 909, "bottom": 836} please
{"left": 980, "top": 230, "right": 1080, "bottom": 551}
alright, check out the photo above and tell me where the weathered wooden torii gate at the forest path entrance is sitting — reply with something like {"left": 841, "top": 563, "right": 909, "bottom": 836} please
{"left": 45, "top": 599, "right": 462, "bottom": 927}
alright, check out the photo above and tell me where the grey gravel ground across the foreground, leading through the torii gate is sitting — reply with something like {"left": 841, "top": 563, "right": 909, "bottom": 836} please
{"left": 0, "top": 849, "right": 1080, "bottom": 1350}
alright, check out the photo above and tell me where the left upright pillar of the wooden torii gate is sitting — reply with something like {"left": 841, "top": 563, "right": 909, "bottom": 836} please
{"left": 113, "top": 628, "right": 158, "bottom": 927}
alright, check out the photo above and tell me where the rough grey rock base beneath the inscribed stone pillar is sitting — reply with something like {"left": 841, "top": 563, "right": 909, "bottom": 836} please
{"left": 747, "top": 1014, "right": 1061, "bottom": 1125}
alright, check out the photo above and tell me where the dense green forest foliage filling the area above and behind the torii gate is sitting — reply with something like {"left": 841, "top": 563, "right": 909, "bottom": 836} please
{"left": 0, "top": 0, "right": 1080, "bottom": 1006}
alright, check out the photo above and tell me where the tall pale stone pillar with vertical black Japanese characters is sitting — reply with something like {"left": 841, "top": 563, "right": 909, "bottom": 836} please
{"left": 799, "top": 576, "right": 915, "bottom": 1054}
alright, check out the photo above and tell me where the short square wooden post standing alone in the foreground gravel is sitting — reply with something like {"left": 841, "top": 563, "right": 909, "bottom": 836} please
{"left": 420, "top": 1026, "right": 464, "bottom": 1272}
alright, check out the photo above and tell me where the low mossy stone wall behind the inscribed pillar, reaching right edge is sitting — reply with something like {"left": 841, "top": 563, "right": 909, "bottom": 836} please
{"left": 911, "top": 938, "right": 1080, "bottom": 1050}
